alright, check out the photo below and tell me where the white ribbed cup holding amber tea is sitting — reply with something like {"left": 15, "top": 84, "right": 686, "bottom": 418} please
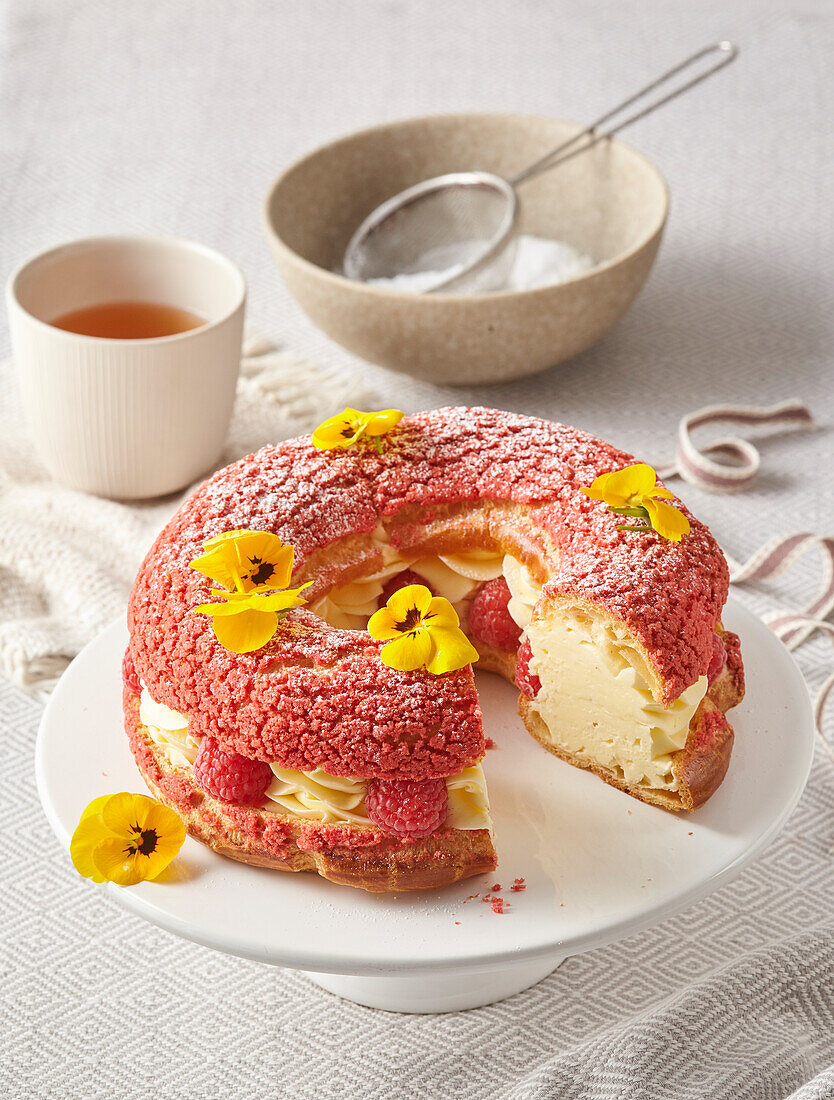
{"left": 7, "top": 237, "right": 246, "bottom": 499}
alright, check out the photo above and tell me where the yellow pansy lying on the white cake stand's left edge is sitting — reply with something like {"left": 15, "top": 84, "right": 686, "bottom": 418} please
{"left": 69, "top": 791, "right": 185, "bottom": 887}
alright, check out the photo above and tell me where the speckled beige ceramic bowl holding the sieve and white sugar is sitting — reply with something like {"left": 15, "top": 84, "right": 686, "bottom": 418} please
{"left": 264, "top": 114, "right": 668, "bottom": 384}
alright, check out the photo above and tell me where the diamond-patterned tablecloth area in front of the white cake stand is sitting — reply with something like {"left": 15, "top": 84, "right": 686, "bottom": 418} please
{"left": 0, "top": 684, "right": 834, "bottom": 1100}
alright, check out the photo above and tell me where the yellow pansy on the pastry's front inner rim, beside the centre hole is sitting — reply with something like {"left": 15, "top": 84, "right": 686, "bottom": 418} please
{"left": 367, "top": 584, "right": 478, "bottom": 675}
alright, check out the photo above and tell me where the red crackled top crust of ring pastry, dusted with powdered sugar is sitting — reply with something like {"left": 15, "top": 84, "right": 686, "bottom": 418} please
{"left": 129, "top": 408, "right": 728, "bottom": 779}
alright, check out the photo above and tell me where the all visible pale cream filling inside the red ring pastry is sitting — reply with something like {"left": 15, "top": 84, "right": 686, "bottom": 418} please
{"left": 140, "top": 525, "right": 707, "bottom": 831}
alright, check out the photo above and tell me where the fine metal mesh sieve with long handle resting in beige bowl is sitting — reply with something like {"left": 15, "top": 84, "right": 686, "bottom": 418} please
{"left": 343, "top": 42, "right": 738, "bottom": 294}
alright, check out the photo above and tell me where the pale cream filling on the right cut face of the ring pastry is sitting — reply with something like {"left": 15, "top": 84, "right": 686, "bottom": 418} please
{"left": 527, "top": 608, "right": 707, "bottom": 791}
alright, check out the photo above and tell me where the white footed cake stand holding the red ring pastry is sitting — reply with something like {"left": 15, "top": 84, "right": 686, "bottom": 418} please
{"left": 36, "top": 601, "right": 814, "bottom": 1012}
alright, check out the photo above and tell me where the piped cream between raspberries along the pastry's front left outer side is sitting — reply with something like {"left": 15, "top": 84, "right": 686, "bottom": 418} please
{"left": 139, "top": 688, "right": 492, "bottom": 833}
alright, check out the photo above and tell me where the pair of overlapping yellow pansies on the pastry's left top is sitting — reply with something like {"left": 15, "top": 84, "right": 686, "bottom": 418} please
{"left": 190, "top": 531, "right": 312, "bottom": 653}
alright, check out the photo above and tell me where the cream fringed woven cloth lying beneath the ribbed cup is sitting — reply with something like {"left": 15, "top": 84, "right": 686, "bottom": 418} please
{"left": 0, "top": 336, "right": 372, "bottom": 694}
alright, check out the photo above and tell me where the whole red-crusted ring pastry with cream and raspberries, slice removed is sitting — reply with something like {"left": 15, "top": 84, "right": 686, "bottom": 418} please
{"left": 124, "top": 408, "right": 744, "bottom": 890}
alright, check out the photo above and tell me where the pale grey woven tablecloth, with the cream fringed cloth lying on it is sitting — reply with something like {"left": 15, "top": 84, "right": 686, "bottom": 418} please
{"left": 0, "top": 0, "right": 834, "bottom": 1100}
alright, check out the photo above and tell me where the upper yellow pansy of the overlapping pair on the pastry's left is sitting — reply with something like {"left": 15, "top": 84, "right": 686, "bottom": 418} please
{"left": 190, "top": 531, "right": 294, "bottom": 592}
